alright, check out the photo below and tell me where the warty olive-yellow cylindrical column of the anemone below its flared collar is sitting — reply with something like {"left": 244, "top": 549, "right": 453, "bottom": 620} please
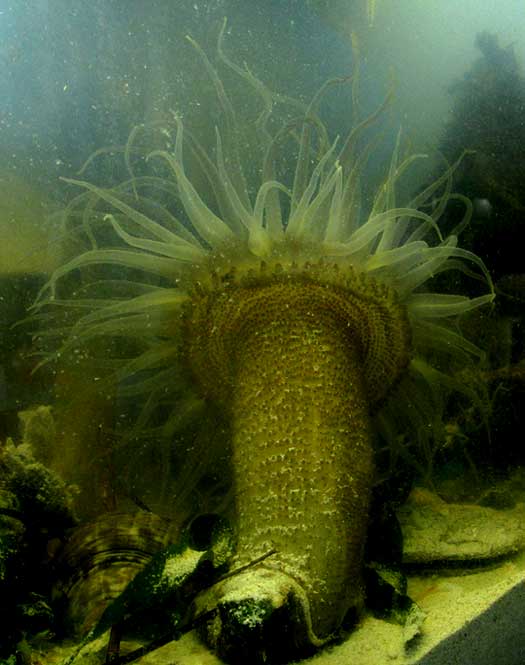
{"left": 232, "top": 286, "right": 372, "bottom": 637}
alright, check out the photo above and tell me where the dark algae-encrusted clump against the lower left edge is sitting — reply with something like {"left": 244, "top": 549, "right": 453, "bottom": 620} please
{"left": 0, "top": 430, "right": 75, "bottom": 657}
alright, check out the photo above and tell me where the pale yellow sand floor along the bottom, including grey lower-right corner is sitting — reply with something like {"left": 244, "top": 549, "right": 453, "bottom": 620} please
{"left": 39, "top": 553, "right": 525, "bottom": 665}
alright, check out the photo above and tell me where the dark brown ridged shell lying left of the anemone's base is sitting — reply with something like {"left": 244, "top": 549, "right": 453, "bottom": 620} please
{"left": 55, "top": 512, "right": 180, "bottom": 636}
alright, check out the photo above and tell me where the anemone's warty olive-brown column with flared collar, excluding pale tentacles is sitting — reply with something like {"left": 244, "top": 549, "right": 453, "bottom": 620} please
{"left": 187, "top": 264, "right": 410, "bottom": 640}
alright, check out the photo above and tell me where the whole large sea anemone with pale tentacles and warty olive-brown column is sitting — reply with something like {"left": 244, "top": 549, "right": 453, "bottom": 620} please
{"left": 32, "top": 23, "right": 493, "bottom": 660}
